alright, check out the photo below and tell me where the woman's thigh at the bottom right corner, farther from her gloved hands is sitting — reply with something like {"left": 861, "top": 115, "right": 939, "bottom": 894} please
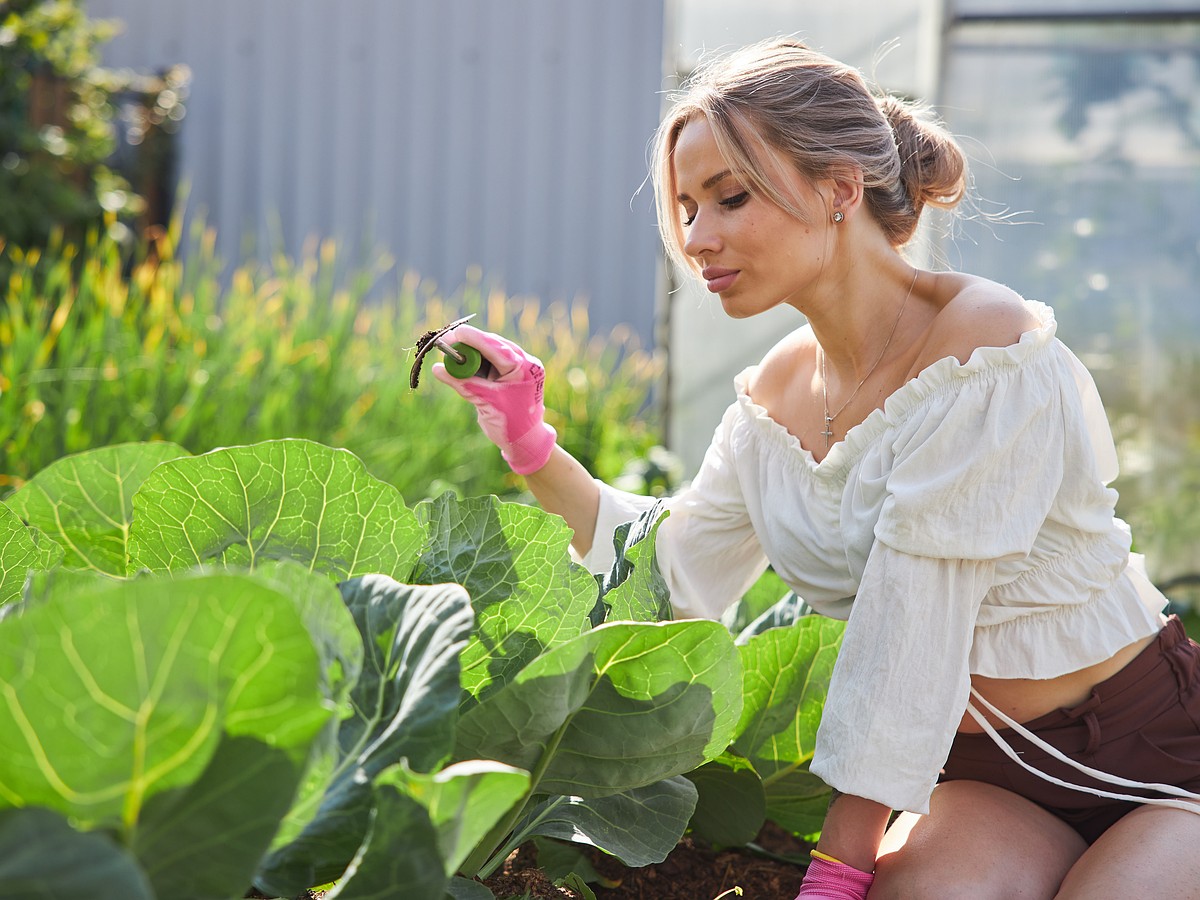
{"left": 1058, "top": 806, "right": 1200, "bottom": 900}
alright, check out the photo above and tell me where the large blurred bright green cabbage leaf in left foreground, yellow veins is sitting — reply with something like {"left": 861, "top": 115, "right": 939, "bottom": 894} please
{"left": 0, "top": 574, "right": 330, "bottom": 827}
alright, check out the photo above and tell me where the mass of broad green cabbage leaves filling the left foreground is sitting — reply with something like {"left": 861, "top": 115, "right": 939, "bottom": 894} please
{"left": 0, "top": 439, "right": 838, "bottom": 900}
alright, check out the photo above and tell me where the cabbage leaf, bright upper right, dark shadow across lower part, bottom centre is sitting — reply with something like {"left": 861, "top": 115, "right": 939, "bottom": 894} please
{"left": 455, "top": 619, "right": 742, "bottom": 798}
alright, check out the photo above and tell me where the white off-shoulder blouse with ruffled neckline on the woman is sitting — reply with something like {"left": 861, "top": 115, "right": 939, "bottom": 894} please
{"left": 583, "top": 302, "right": 1166, "bottom": 812}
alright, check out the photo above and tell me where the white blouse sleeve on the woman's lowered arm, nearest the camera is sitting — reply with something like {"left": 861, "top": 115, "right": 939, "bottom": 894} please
{"left": 810, "top": 343, "right": 1094, "bottom": 812}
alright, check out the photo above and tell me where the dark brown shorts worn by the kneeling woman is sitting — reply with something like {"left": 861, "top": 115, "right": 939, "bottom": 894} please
{"left": 940, "top": 616, "right": 1200, "bottom": 844}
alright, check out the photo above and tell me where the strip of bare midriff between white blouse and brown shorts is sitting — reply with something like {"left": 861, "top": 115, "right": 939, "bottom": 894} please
{"left": 959, "top": 635, "right": 1156, "bottom": 734}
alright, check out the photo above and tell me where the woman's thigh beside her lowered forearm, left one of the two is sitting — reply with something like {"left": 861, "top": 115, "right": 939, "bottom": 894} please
{"left": 870, "top": 781, "right": 1087, "bottom": 900}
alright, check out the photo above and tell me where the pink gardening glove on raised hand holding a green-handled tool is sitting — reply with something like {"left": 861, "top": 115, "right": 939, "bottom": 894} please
{"left": 433, "top": 325, "right": 558, "bottom": 475}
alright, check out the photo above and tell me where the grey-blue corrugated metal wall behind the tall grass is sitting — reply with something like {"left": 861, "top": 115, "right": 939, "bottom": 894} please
{"left": 86, "top": 0, "right": 664, "bottom": 341}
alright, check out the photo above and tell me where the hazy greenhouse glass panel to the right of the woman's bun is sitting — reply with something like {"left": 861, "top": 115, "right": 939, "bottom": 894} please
{"left": 938, "top": 21, "right": 1200, "bottom": 592}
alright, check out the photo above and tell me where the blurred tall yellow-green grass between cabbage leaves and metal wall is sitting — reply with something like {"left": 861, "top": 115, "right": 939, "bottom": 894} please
{"left": 0, "top": 217, "right": 662, "bottom": 502}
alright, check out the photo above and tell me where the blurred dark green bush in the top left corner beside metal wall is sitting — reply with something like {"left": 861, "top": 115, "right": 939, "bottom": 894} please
{"left": 0, "top": 0, "right": 143, "bottom": 254}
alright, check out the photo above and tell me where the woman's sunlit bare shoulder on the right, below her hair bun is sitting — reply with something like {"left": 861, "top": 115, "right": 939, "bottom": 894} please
{"left": 922, "top": 276, "right": 1039, "bottom": 365}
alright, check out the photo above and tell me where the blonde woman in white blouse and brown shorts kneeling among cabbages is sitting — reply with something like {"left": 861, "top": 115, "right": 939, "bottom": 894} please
{"left": 436, "top": 40, "right": 1200, "bottom": 900}
